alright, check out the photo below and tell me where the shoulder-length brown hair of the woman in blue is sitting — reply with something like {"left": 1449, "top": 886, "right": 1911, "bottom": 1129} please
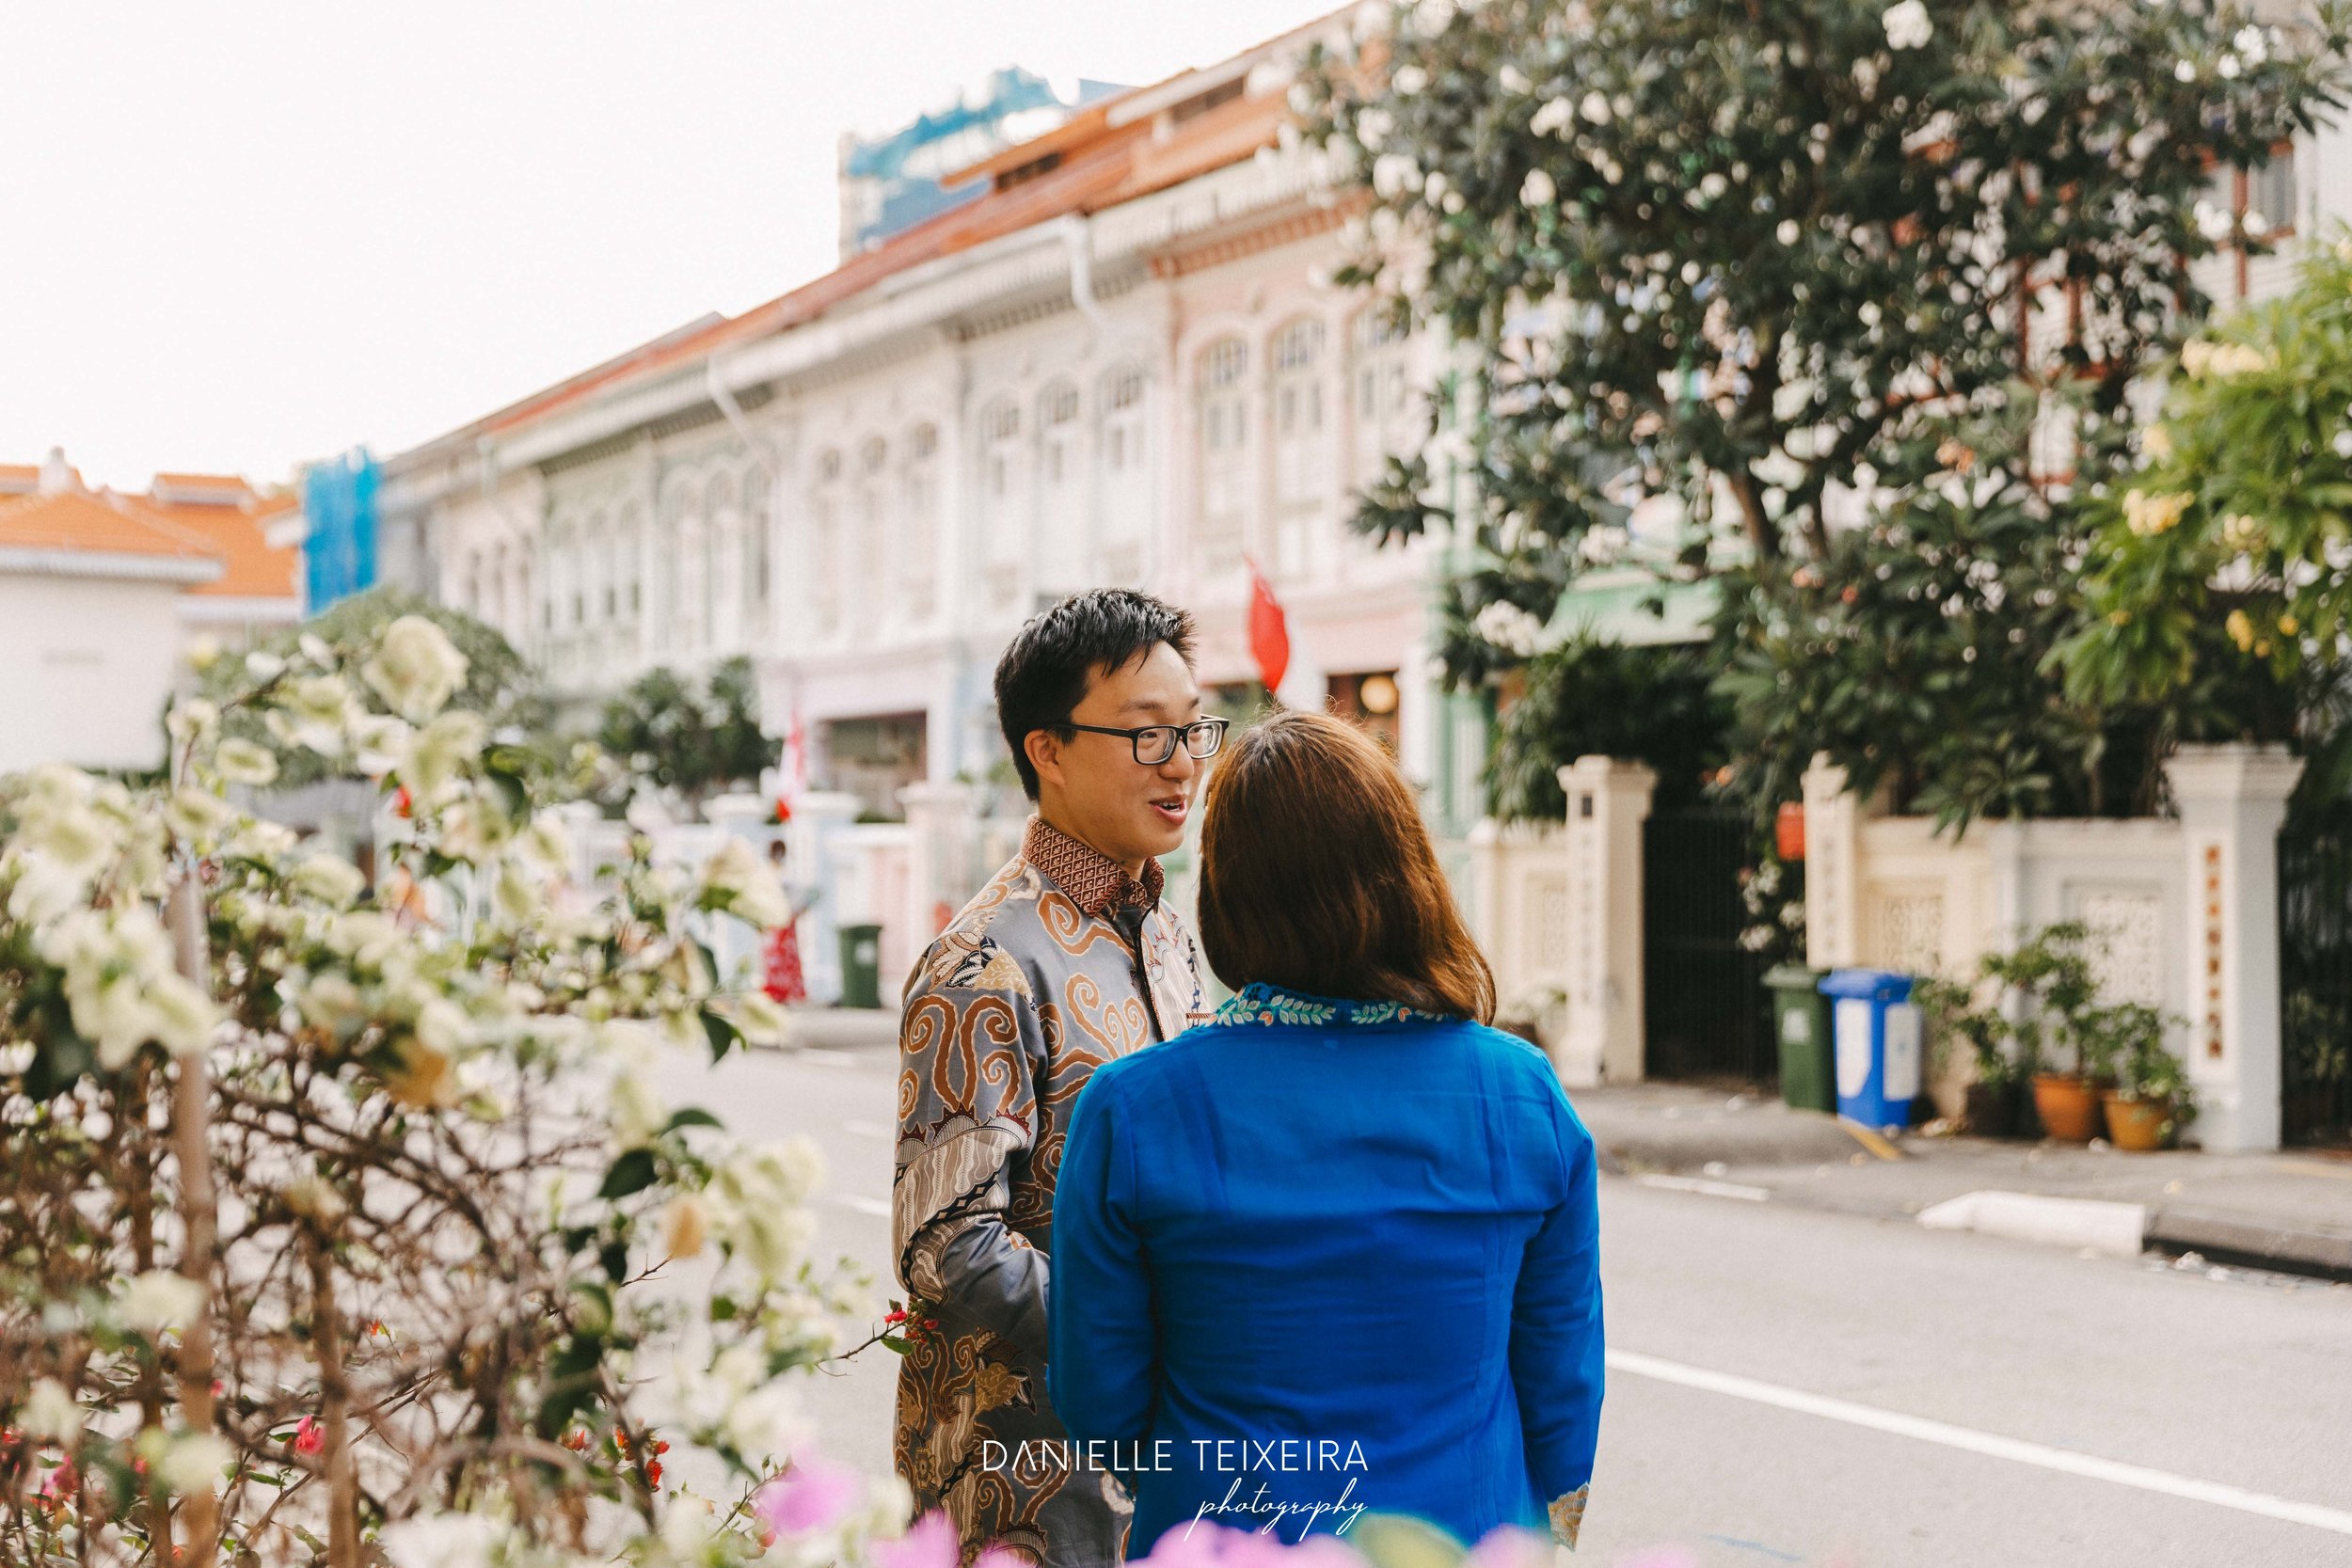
{"left": 1200, "top": 712, "right": 1494, "bottom": 1022}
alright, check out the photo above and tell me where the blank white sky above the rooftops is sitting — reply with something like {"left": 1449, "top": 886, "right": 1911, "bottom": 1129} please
{"left": 0, "top": 0, "right": 1339, "bottom": 489}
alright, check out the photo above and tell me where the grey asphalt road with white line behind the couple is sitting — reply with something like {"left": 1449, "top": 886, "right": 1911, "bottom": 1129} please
{"left": 668, "top": 1021, "right": 2352, "bottom": 1568}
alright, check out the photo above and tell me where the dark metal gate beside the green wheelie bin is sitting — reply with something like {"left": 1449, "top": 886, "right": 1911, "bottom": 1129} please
{"left": 1642, "top": 809, "right": 1781, "bottom": 1084}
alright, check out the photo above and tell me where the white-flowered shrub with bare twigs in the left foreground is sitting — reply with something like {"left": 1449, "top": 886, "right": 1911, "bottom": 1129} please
{"left": 0, "top": 616, "right": 906, "bottom": 1568}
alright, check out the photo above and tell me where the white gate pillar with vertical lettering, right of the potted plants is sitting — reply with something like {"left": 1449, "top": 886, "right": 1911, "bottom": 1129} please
{"left": 2164, "top": 745, "right": 2303, "bottom": 1154}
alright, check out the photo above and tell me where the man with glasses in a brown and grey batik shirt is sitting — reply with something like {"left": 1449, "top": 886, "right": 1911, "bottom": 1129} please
{"left": 892, "top": 588, "right": 1226, "bottom": 1568}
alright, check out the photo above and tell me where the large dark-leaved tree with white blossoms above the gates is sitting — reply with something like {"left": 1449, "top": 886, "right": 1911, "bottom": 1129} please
{"left": 1306, "top": 0, "right": 2345, "bottom": 825}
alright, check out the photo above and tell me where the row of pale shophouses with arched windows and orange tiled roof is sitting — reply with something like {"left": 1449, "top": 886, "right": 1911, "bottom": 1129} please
{"left": 381, "top": 6, "right": 1482, "bottom": 991}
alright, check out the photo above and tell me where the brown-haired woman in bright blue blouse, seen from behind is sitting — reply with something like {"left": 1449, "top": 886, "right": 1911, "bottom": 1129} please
{"left": 1049, "top": 712, "right": 1602, "bottom": 1559}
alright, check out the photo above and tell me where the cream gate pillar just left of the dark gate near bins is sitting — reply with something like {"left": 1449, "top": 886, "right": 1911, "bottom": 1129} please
{"left": 1560, "top": 757, "right": 1659, "bottom": 1086}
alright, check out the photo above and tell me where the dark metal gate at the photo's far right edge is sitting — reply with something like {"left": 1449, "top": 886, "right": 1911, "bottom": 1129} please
{"left": 2280, "top": 820, "right": 2352, "bottom": 1145}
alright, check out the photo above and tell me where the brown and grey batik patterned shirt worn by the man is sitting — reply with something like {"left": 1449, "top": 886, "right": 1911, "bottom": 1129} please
{"left": 892, "top": 818, "right": 1209, "bottom": 1568}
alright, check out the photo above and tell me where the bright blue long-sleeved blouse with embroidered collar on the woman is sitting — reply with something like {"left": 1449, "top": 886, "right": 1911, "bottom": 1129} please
{"left": 1047, "top": 985, "right": 1602, "bottom": 1561}
